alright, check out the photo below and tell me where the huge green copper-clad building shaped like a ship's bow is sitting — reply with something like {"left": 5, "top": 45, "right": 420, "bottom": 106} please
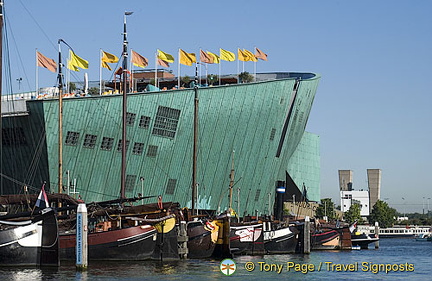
{"left": 1, "top": 73, "right": 320, "bottom": 214}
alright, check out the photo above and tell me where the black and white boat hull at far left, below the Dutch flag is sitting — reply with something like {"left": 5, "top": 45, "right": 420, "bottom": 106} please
{"left": 0, "top": 209, "right": 59, "bottom": 267}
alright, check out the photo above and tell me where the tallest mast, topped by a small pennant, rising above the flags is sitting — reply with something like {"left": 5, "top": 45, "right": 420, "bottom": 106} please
{"left": 120, "top": 12, "right": 133, "bottom": 199}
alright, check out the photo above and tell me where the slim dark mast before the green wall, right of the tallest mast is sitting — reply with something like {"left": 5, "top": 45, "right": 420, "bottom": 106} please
{"left": 192, "top": 64, "right": 198, "bottom": 215}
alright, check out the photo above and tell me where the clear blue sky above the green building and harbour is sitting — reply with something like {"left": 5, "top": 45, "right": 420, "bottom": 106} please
{"left": 3, "top": 0, "right": 432, "bottom": 213}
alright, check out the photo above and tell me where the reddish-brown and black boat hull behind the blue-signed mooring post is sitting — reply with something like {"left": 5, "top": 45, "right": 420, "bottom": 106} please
{"left": 60, "top": 225, "right": 157, "bottom": 260}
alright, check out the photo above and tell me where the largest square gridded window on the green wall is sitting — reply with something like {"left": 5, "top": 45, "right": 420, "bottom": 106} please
{"left": 152, "top": 106, "right": 180, "bottom": 139}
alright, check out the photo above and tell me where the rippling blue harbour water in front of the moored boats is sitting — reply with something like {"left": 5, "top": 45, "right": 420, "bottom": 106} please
{"left": 0, "top": 239, "right": 432, "bottom": 281}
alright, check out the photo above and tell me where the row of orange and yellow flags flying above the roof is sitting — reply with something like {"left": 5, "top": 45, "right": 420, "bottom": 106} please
{"left": 36, "top": 48, "right": 267, "bottom": 72}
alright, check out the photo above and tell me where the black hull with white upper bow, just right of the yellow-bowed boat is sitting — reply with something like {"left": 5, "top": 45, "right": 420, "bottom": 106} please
{"left": 230, "top": 224, "right": 266, "bottom": 255}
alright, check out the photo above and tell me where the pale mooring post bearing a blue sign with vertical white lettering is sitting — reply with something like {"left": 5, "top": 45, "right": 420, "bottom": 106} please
{"left": 76, "top": 204, "right": 88, "bottom": 271}
